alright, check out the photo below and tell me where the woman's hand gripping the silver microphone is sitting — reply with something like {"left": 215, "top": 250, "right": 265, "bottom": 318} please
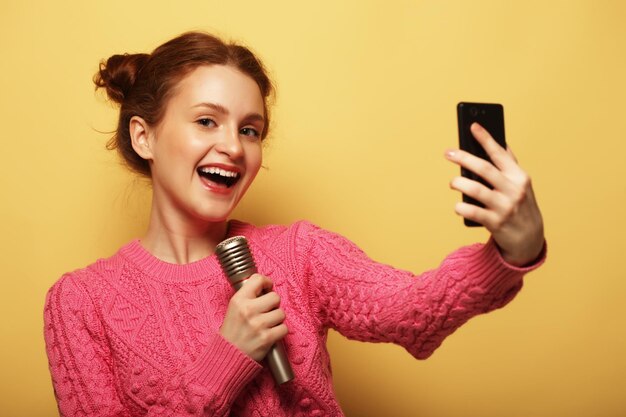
{"left": 220, "top": 274, "right": 287, "bottom": 362}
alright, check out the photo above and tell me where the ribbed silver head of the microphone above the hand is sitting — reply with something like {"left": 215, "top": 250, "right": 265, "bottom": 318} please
{"left": 215, "top": 236, "right": 257, "bottom": 285}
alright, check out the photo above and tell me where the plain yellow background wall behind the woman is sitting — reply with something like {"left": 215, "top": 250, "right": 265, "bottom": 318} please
{"left": 0, "top": 0, "right": 626, "bottom": 417}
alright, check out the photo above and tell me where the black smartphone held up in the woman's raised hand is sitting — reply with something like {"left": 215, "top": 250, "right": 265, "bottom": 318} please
{"left": 456, "top": 102, "right": 506, "bottom": 227}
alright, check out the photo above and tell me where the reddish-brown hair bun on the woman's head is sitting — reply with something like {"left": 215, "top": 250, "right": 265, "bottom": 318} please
{"left": 93, "top": 54, "right": 150, "bottom": 105}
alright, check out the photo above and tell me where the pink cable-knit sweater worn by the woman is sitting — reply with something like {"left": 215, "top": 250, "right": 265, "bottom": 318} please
{"left": 44, "top": 221, "right": 543, "bottom": 417}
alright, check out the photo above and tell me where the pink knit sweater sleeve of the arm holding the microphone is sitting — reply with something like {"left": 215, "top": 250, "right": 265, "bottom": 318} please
{"left": 44, "top": 274, "right": 261, "bottom": 417}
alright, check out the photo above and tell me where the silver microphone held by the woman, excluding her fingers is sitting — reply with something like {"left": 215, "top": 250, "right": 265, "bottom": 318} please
{"left": 215, "top": 236, "right": 294, "bottom": 384}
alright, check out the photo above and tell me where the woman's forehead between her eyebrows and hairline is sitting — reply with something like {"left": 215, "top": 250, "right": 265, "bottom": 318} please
{"left": 168, "top": 65, "right": 265, "bottom": 114}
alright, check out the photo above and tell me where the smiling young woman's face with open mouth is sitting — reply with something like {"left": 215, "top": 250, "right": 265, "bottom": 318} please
{"left": 149, "top": 65, "right": 265, "bottom": 226}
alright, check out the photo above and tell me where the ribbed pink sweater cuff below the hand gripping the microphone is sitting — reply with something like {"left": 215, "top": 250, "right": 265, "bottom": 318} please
{"left": 187, "top": 333, "right": 263, "bottom": 401}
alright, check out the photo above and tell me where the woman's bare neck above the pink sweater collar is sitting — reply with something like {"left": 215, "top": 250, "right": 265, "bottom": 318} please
{"left": 141, "top": 201, "right": 228, "bottom": 264}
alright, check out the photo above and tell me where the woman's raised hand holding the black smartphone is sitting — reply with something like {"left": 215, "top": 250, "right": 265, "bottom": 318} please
{"left": 446, "top": 123, "right": 544, "bottom": 266}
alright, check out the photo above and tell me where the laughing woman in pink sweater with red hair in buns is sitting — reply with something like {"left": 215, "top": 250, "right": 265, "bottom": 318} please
{"left": 45, "top": 32, "right": 545, "bottom": 416}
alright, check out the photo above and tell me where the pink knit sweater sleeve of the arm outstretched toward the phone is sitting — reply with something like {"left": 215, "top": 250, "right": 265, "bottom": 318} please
{"left": 297, "top": 223, "right": 545, "bottom": 359}
